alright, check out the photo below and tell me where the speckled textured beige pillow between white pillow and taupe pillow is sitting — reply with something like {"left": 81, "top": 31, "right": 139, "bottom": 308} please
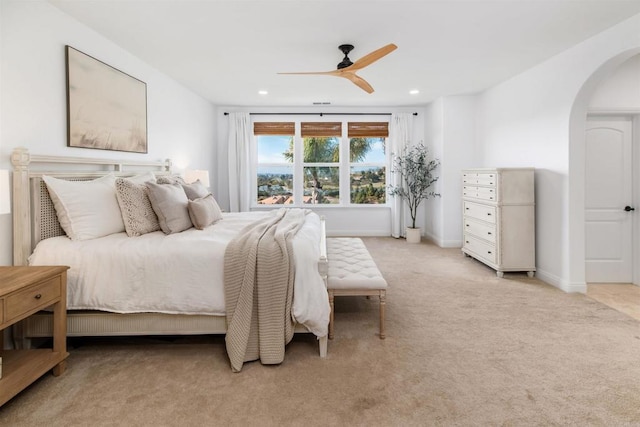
{"left": 116, "top": 174, "right": 160, "bottom": 237}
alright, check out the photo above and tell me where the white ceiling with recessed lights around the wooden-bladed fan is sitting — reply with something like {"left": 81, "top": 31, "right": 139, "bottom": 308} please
{"left": 49, "top": 0, "right": 640, "bottom": 107}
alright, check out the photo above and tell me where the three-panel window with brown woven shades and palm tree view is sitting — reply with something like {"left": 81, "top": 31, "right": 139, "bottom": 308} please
{"left": 254, "top": 121, "right": 388, "bottom": 206}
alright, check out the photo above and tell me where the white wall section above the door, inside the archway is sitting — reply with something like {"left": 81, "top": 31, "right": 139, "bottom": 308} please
{"left": 589, "top": 55, "right": 640, "bottom": 114}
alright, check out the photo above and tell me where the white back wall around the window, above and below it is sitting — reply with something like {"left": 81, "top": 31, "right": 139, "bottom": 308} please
{"left": 212, "top": 107, "right": 425, "bottom": 236}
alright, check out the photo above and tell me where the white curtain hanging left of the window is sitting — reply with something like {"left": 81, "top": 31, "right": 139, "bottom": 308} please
{"left": 228, "top": 113, "right": 253, "bottom": 212}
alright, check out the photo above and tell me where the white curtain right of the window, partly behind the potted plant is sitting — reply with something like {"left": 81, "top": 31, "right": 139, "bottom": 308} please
{"left": 389, "top": 113, "right": 413, "bottom": 238}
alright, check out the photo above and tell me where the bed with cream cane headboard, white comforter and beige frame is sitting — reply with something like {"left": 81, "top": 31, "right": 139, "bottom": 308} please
{"left": 11, "top": 148, "right": 329, "bottom": 368}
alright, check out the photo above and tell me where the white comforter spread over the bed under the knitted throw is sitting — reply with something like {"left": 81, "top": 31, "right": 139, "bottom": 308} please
{"left": 29, "top": 212, "right": 330, "bottom": 336}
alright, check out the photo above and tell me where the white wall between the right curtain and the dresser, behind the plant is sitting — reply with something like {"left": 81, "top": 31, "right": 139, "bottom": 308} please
{"left": 425, "top": 95, "right": 479, "bottom": 248}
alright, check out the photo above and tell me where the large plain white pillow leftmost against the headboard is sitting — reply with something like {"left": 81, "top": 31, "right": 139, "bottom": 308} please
{"left": 42, "top": 174, "right": 124, "bottom": 240}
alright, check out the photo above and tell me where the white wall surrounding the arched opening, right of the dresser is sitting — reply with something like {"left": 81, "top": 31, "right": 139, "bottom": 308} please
{"left": 478, "top": 15, "right": 640, "bottom": 292}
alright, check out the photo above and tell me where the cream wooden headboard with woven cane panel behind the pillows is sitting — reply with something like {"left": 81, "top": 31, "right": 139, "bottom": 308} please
{"left": 11, "top": 148, "right": 171, "bottom": 265}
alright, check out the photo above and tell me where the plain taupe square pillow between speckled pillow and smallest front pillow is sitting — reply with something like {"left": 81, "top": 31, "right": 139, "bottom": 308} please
{"left": 147, "top": 182, "right": 193, "bottom": 234}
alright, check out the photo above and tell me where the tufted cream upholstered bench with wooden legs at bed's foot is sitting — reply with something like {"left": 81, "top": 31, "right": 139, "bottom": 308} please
{"left": 327, "top": 237, "right": 387, "bottom": 339}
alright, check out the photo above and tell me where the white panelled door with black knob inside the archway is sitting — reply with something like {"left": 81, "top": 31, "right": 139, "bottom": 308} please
{"left": 585, "top": 119, "right": 634, "bottom": 283}
